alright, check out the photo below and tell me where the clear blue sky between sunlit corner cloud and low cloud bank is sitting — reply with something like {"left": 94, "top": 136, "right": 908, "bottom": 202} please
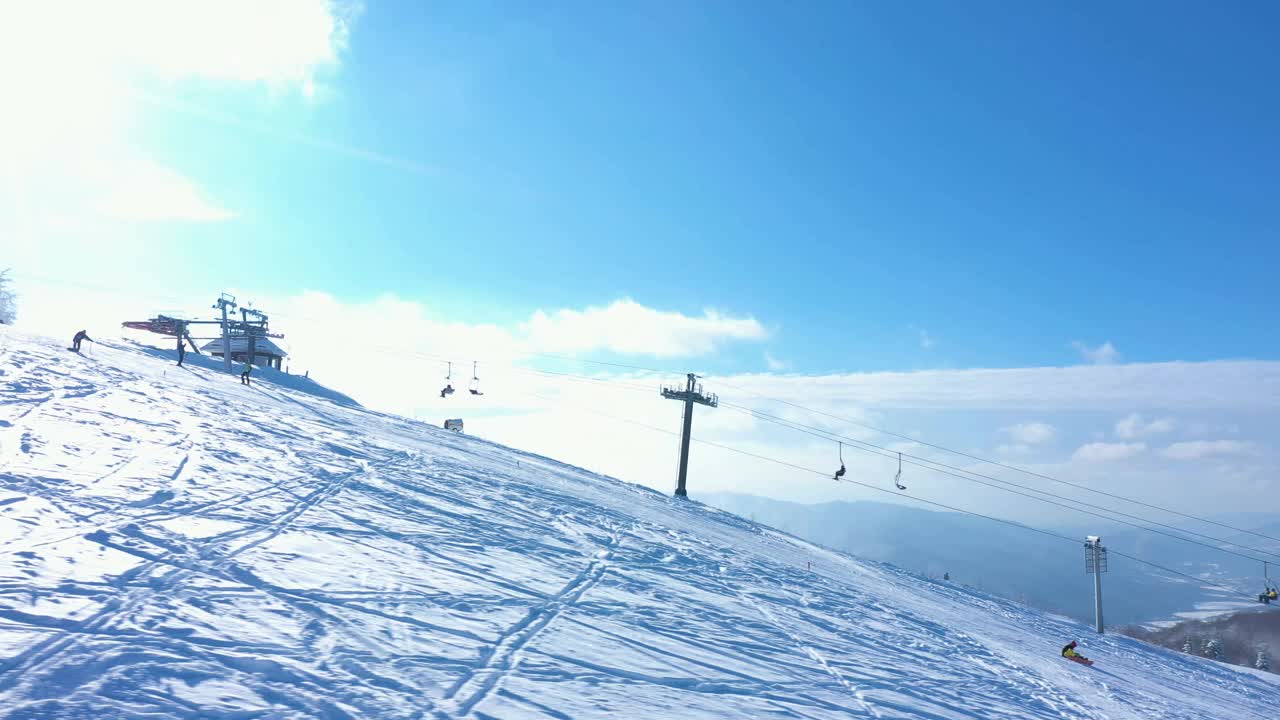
{"left": 10, "top": 3, "right": 1280, "bottom": 372}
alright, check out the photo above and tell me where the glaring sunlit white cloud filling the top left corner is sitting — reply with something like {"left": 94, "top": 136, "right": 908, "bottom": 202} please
{"left": 0, "top": 0, "right": 356, "bottom": 226}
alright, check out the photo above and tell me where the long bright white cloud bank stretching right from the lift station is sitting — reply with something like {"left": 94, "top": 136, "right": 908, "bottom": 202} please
{"left": 147, "top": 290, "right": 754, "bottom": 412}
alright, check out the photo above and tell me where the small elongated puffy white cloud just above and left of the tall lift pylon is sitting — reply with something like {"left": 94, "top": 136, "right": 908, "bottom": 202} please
{"left": 521, "top": 300, "right": 768, "bottom": 357}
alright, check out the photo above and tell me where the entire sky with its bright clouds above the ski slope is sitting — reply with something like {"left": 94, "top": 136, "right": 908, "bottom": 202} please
{"left": 0, "top": 0, "right": 1280, "bottom": 509}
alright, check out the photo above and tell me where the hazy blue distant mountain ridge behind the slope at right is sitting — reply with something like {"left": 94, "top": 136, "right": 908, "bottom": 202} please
{"left": 699, "top": 493, "right": 1280, "bottom": 624}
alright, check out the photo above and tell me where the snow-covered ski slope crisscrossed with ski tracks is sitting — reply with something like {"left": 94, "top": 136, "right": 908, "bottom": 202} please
{"left": 0, "top": 327, "right": 1280, "bottom": 720}
